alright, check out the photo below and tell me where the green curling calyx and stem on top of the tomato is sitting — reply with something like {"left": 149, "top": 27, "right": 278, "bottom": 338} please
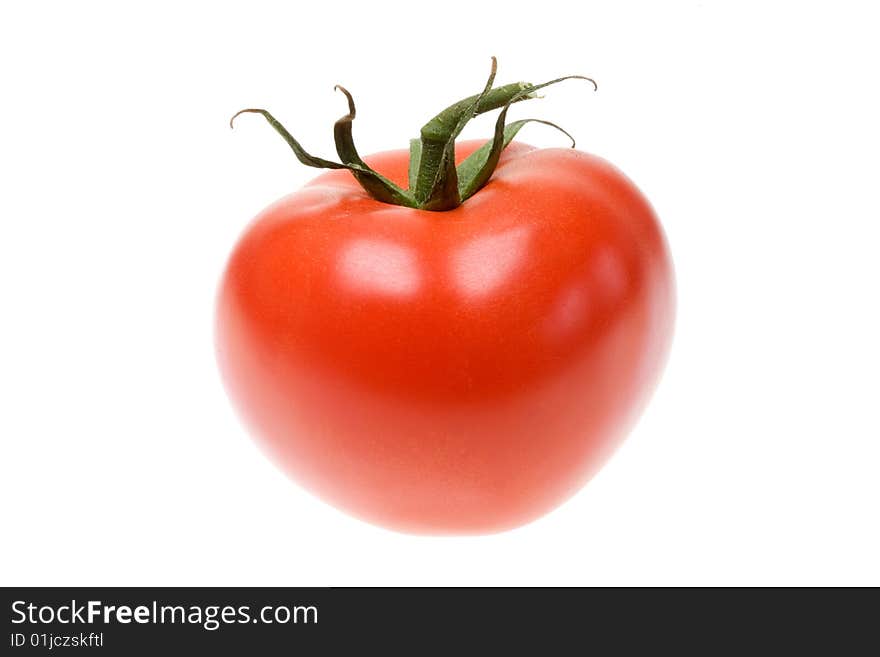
{"left": 229, "top": 57, "right": 598, "bottom": 212}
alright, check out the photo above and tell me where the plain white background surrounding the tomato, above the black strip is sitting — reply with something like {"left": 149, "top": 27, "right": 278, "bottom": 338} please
{"left": 0, "top": 0, "right": 880, "bottom": 585}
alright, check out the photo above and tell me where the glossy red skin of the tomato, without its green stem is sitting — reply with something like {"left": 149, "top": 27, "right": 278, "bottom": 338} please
{"left": 216, "top": 142, "right": 674, "bottom": 534}
